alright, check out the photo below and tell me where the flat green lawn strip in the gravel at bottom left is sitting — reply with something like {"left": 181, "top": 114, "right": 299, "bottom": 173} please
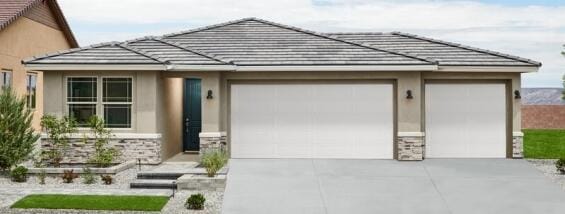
{"left": 12, "top": 195, "right": 169, "bottom": 211}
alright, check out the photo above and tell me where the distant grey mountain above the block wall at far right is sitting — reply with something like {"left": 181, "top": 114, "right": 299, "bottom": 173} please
{"left": 522, "top": 88, "right": 565, "bottom": 105}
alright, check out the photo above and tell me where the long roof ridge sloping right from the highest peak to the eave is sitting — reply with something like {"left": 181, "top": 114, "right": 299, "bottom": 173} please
{"left": 246, "top": 18, "right": 438, "bottom": 64}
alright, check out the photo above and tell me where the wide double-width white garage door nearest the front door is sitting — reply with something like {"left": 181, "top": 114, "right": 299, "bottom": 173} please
{"left": 230, "top": 84, "right": 393, "bottom": 159}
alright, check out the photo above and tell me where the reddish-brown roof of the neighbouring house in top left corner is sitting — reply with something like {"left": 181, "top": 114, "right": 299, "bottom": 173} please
{"left": 0, "top": 0, "right": 78, "bottom": 47}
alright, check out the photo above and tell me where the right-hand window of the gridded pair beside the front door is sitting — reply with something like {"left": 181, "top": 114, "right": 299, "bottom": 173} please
{"left": 102, "top": 77, "right": 132, "bottom": 128}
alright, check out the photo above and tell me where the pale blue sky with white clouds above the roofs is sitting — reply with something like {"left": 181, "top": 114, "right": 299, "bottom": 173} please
{"left": 59, "top": 0, "right": 565, "bottom": 87}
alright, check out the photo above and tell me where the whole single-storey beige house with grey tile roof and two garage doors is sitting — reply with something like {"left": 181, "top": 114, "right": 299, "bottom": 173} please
{"left": 25, "top": 18, "right": 541, "bottom": 163}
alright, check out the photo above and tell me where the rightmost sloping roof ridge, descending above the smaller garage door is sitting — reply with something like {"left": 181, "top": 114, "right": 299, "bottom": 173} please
{"left": 391, "top": 31, "right": 541, "bottom": 66}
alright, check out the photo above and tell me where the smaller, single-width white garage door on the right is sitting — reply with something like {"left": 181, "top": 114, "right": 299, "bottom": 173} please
{"left": 425, "top": 84, "right": 506, "bottom": 158}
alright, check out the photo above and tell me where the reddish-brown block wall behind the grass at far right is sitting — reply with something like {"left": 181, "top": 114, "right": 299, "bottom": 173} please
{"left": 522, "top": 105, "right": 565, "bottom": 129}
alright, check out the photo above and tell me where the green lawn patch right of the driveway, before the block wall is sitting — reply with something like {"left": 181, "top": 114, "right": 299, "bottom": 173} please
{"left": 523, "top": 129, "right": 565, "bottom": 159}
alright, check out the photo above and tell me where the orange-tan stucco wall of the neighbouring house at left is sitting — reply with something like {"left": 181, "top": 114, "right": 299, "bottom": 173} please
{"left": 0, "top": 17, "right": 70, "bottom": 129}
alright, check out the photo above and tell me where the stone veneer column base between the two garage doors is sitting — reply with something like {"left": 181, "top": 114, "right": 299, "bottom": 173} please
{"left": 396, "top": 132, "right": 425, "bottom": 161}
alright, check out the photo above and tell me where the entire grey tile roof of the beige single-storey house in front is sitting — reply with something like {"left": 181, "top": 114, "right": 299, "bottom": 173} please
{"left": 25, "top": 18, "right": 539, "bottom": 66}
